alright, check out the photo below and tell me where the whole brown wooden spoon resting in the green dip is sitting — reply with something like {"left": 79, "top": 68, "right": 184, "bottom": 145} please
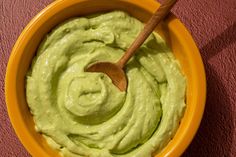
{"left": 85, "top": 0, "right": 176, "bottom": 91}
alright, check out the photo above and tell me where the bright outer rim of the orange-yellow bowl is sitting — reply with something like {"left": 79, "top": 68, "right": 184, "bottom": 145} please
{"left": 5, "top": 0, "right": 206, "bottom": 157}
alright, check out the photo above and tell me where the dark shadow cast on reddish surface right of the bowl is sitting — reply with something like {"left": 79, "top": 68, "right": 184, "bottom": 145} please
{"left": 183, "top": 21, "right": 236, "bottom": 157}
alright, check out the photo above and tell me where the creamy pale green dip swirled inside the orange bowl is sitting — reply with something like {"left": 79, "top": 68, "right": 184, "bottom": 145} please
{"left": 26, "top": 11, "right": 186, "bottom": 157}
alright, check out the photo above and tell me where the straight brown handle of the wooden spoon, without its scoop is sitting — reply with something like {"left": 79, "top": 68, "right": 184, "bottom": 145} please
{"left": 116, "top": 0, "right": 176, "bottom": 68}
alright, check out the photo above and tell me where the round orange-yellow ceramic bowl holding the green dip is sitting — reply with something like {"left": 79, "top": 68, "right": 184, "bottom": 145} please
{"left": 5, "top": 0, "right": 206, "bottom": 157}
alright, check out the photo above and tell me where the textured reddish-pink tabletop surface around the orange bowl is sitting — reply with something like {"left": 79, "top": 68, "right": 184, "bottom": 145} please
{"left": 0, "top": 0, "right": 236, "bottom": 157}
